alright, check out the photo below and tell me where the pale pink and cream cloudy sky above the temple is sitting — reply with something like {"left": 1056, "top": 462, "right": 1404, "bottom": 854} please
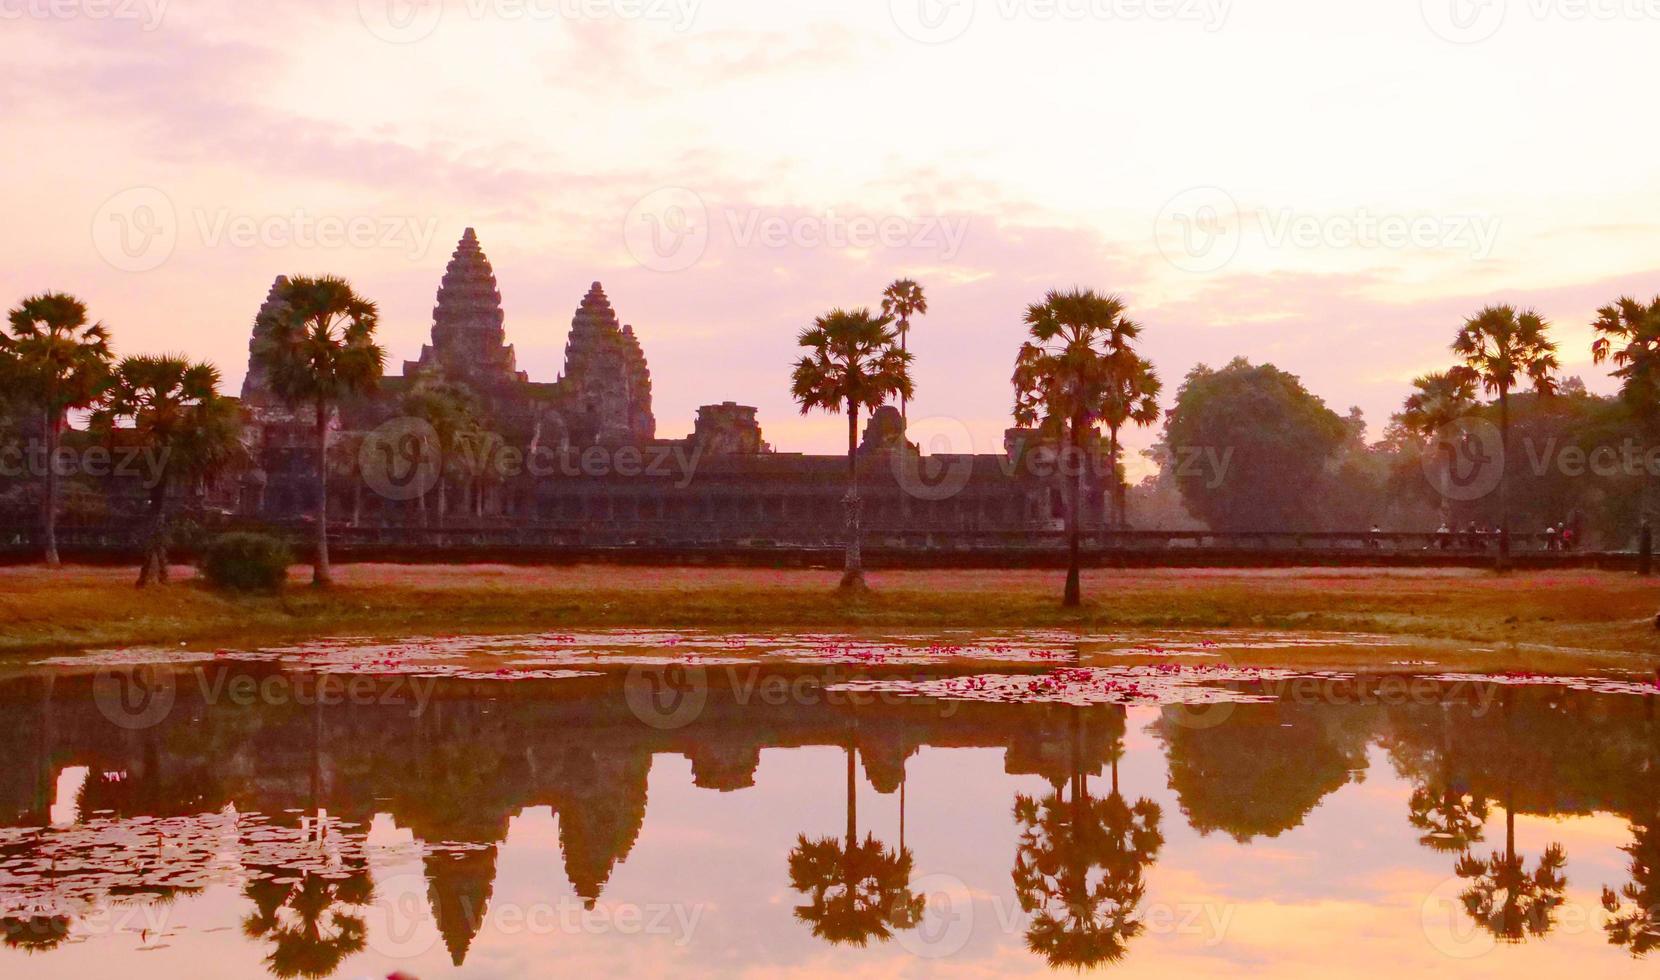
{"left": 0, "top": 0, "right": 1660, "bottom": 471}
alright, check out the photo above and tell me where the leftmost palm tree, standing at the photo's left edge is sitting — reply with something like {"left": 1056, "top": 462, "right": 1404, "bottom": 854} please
{"left": 0, "top": 292, "right": 111, "bottom": 568}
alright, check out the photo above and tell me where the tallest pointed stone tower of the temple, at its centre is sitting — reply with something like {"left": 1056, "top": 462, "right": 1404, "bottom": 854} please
{"left": 403, "top": 228, "right": 528, "bottom": 392}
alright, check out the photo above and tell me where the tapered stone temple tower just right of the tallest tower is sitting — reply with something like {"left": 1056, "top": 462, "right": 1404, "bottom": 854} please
{"left": 558, "top": 282, "right": 657, "bottom": 445}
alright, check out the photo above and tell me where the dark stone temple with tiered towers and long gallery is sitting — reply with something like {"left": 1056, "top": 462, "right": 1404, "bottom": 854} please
{"left": 231, "top": 229, "right": 1102, "bottom": 545}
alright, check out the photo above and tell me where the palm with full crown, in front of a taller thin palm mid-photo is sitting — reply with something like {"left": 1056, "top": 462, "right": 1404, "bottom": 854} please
{"left": 790, "top": 309, "right": 913, "bottom": 591}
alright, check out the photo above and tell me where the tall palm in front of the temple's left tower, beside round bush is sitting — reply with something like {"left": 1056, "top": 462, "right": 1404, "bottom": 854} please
{"left": 254, "top": 276, "right": 387, "bottom": 586}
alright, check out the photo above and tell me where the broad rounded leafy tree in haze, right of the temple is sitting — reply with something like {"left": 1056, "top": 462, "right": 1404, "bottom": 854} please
{"left": 1164, "top": 357, "right": 1351, "bottom": 532}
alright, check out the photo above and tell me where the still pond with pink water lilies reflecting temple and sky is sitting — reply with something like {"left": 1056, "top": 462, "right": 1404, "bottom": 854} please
{"left": 0, "top": 631, "right": 1660, "bottom": 978}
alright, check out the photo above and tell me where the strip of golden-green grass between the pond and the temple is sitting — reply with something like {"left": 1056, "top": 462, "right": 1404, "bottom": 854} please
{"left": 0, "top": 565, "right": 1660, "bottom": 668}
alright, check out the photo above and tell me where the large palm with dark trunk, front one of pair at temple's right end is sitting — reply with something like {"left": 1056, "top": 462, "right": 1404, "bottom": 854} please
{"left": 1013, "top": 289, "right": 1139, "bottom": 606}
